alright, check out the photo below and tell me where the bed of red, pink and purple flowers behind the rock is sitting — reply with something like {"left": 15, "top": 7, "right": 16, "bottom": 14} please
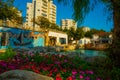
{"left": 0, "top": 53, "right": 106, "bottom": 80}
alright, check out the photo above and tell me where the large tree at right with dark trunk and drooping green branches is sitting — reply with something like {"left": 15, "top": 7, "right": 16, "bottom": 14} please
{"left": 58, "top": 0, "right": 120, "bottom": 67}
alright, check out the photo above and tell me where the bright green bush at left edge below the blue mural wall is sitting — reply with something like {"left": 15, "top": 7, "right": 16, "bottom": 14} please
{"left": 0, "top": 47, "right": 16, "bottom": 60}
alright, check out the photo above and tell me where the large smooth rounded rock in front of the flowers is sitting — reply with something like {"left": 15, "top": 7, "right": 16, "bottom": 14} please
{"left": 0, "top": 70, "right": 54, "bottom": 80}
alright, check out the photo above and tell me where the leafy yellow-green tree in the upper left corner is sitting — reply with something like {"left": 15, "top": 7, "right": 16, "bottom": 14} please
{"left": 0, "top": 0, "right": 22, "bottom": 24}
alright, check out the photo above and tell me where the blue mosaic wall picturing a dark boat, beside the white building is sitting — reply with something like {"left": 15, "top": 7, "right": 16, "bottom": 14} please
{"left": 0, "top": 27, "right": 44, "bottom": 49}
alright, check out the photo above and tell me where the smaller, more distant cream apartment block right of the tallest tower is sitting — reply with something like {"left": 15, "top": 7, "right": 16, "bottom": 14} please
{"left": 61, "top": 19, "right": 77, "bottom": 30}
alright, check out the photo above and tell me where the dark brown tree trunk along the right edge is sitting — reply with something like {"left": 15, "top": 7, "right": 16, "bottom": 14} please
{"left": 111, "top": 0, "right": 120, "bottom": 66}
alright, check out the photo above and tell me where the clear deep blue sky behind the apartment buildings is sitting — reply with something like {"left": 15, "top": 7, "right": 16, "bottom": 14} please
{"left": 14, "top": 0, "right": 113, "bottom": 31}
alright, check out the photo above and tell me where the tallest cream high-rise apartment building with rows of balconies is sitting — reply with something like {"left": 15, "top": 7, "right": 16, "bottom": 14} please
{"left": 26, "top": 0, "right": 56, "bottom": 26}
